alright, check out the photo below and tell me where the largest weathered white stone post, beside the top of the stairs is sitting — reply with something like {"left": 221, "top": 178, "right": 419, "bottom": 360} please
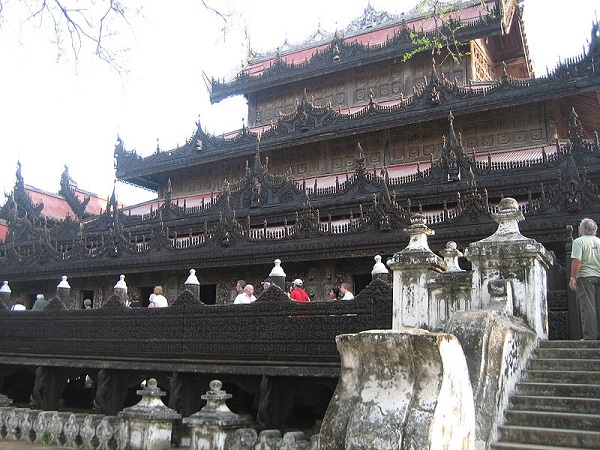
{"left": 465, "top": 197, "right": 553, "bottom": 339}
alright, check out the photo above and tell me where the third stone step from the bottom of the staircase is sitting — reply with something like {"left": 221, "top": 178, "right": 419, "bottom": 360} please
{"left": 509, "top": 395, "right": 600, "bottom": 414}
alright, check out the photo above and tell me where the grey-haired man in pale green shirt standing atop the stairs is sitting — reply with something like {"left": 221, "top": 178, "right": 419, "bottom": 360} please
{"left": 569, "top": 218, "right": 600, "bottom": 340}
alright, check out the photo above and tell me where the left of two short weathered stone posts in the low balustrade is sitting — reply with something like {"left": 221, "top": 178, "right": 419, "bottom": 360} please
{"left": 119, "top": 378, "right": 180, "bottom": 450}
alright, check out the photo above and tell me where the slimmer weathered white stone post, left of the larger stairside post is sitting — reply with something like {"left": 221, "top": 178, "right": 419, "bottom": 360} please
{"left": 387, "top": 214, "right": 446, "bottom": 330}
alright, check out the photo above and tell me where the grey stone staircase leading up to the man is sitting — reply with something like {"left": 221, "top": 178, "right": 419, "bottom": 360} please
{"left": 491, "top": 341, "right": 600, "bottom": 450}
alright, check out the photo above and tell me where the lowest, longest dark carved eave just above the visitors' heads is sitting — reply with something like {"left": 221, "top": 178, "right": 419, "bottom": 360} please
{"left": 7, "top": 127, "right": 600, "bottom": 280}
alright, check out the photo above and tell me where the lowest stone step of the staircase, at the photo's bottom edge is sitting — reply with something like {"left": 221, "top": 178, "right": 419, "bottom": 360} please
{"left": 498, "top": 425, "right": 600, "bottom": 450}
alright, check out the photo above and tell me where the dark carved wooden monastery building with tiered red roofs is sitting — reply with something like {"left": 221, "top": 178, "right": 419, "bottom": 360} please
{"left": 0, "top": 0, "right": 600, "bottom": 328}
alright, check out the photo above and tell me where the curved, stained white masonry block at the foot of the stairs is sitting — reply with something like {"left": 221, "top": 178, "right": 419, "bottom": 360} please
{"left": 319, "top": 329, "right": 475, "bottom": 450}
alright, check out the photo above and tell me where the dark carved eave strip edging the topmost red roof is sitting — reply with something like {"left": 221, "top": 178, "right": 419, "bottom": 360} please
{"left": 210, "top": 0, "right": 508, "bottom": 103}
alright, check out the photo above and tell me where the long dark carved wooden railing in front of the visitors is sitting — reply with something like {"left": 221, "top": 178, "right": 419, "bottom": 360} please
{"left": 0, "top": 281, "right": 392, "bottom": 376}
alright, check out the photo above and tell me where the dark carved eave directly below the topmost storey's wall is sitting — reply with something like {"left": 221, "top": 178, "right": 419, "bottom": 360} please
{"left": 115, "top": 35, "right": 600, "bottom": 189}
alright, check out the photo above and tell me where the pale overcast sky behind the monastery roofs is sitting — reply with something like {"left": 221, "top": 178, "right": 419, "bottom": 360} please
{"left": 0, "top": 0, "right": 599, "bottom": 204}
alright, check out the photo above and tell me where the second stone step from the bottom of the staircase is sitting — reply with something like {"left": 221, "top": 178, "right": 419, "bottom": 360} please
{"left": 505, "top": 410, "right": 600, "bottom": 431}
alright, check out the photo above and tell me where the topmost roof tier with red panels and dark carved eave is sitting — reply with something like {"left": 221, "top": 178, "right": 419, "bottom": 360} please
{"left": 210, "top": 0, "right": 532, "bottom": 102}
